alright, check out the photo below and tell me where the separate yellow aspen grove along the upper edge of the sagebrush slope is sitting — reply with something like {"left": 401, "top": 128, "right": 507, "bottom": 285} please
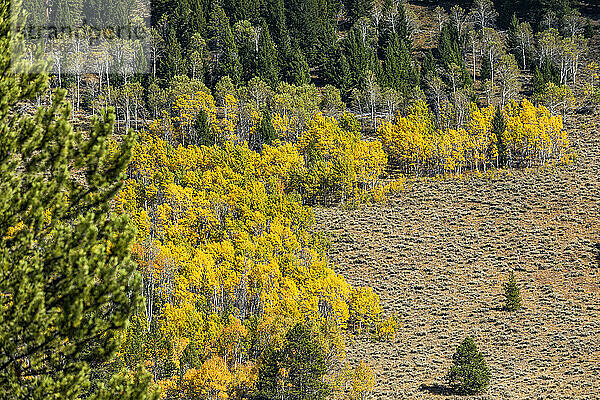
{"left": 378, "top": 100, "right": 569, "bottom": 176}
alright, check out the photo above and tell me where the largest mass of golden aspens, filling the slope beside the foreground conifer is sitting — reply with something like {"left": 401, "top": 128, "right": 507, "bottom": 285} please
{"left": 114, "top": 100, "right": 392, "bottom": 400}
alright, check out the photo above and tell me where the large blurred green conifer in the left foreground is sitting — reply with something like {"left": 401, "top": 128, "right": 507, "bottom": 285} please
{"left": 0, "top": 4, "right": 155, "bottom": 400}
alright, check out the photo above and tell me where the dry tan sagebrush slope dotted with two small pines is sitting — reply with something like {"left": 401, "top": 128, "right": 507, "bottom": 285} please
{"left": 315, "top": 111, "right": 600, "bottom": 400}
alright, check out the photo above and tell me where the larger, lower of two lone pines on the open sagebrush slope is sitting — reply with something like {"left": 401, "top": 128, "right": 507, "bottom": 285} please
{"left": 446, "top": 337, "right": 490, "bottom": 394}
